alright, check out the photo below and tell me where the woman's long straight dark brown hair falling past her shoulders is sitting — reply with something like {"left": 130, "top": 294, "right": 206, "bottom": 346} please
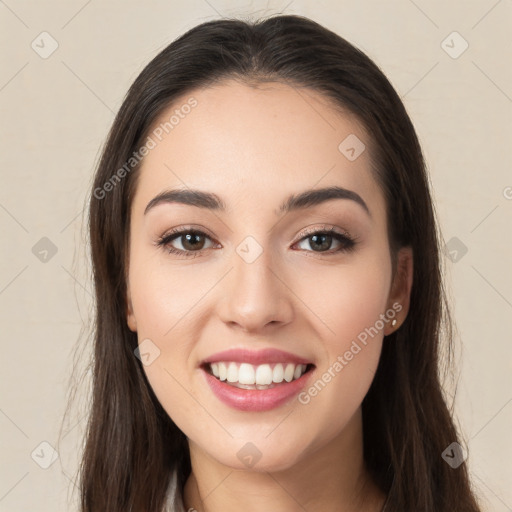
{"left": 74, "top": 15, "right": 480, "bottom": 512}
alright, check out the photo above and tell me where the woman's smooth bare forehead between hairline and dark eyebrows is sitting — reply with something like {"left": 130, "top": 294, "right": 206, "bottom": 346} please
{"left": 133, "top": 80, "right": 383, "bottom": 219}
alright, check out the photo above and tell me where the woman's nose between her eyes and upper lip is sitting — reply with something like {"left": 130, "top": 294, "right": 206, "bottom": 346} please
{"left": 218, "top": 242, "right": 294, "bottom": 334}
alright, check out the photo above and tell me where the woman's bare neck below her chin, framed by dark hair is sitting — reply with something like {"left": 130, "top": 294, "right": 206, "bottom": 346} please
{"left": 184, "top": 409, "right": 385, "bottom": 512}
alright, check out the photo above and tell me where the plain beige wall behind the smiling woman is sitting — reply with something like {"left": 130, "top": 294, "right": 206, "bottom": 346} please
{"left": 0, "top": 0, "right": 512, "bottom": 512}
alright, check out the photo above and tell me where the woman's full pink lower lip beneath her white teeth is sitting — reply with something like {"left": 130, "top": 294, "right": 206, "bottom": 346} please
{"left": 202, "top": 370, "right": 313, "bottom": 412}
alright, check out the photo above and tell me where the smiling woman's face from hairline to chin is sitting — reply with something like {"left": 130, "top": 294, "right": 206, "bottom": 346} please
{"left": 127, "top": 81, "right": 410, "bottom": 470}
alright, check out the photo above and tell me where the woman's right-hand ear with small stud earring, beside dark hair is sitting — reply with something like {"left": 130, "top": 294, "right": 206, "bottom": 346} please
{"left": 384, "top": 247, "right": 414, "bottom": 336}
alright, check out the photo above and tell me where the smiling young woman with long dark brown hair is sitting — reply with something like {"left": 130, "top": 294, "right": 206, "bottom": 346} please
{"left": 81, "top": 16, "right": 479, "bottom": 512}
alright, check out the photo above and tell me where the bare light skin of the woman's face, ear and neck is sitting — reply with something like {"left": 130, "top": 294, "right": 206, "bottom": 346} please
{"left": 127, "top": 80, "right": 412, "bottom": 512}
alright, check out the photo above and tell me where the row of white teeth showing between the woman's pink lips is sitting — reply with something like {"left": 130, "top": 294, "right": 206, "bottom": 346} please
{"left": 202, "top": 361, "right": 315, "bottom": 390}
